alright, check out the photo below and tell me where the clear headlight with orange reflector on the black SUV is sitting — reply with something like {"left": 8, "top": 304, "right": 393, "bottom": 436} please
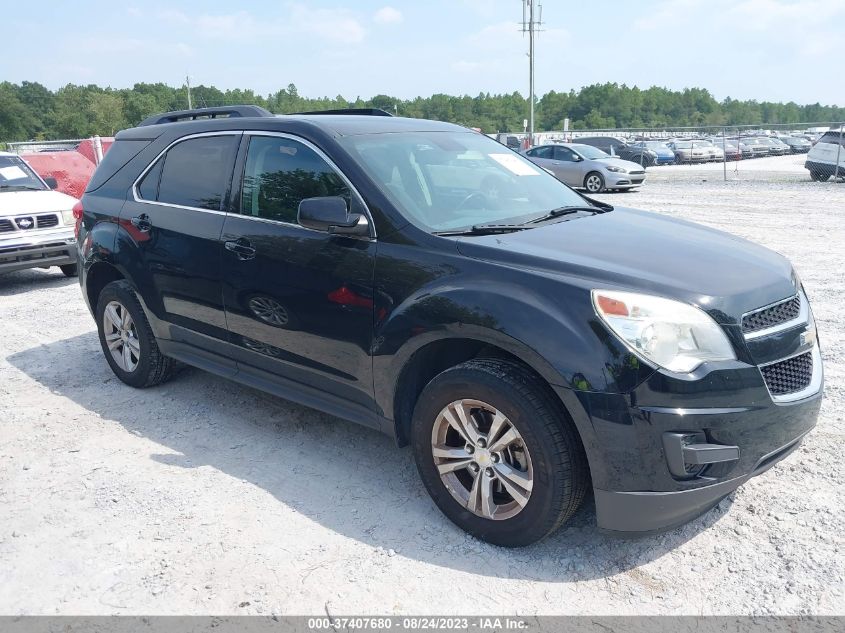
{"left": 592, "top": 290, "right": 736, "bottom": 373}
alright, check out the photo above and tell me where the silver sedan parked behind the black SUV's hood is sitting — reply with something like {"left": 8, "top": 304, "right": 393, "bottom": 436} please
{"left": 522, "top": 143, "right": 645, "bottom": 193}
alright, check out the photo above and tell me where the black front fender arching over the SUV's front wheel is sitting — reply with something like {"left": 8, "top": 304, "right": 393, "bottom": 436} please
{"left": 373, "top": 273, "right": 653, "bottom": 404}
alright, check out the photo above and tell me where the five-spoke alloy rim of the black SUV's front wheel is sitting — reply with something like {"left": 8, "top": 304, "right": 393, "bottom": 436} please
{"left": 431, "top": 399, "right": 534, "bottom": 521}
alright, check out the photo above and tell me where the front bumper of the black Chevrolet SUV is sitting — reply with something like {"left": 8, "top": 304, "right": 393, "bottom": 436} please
{"left": 557, "top": 318, "right": 824, "bottom": 536}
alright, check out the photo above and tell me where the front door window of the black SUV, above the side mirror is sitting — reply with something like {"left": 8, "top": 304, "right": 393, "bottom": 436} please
{"left": 241, "top": 136, "right": 351, "bottom": 224}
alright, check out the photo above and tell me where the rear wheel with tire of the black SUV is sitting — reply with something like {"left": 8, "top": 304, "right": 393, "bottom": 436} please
{"left": 95, "top": 280, "right": 177, "bottom": 388}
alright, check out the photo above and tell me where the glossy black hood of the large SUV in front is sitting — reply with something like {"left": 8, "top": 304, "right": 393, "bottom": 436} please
{"left": 458, "top": 208, "right": 796, "bottom": 323}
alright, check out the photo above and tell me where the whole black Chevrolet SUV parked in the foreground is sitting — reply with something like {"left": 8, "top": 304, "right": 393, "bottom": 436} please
{"left": 78, "top": 106, "right": 822, "bottom": 546}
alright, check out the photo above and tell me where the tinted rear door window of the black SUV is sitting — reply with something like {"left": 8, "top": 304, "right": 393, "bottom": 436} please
{"left": 146, "top": 134, "right": 239, "bottom": 211}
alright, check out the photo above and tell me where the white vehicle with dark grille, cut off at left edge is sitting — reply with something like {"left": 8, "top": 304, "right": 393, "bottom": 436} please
{"left": 0, "top": 152, "right": 77, "bottom": 277}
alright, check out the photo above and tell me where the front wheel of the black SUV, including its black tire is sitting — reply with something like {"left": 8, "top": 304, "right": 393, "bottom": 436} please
{"left": 411, "top": 358, "right": 590, "bottom": 547}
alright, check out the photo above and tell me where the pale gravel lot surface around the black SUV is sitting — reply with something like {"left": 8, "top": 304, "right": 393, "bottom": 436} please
{"left": 0, "top": 157, "right": 845, "bottom": 615}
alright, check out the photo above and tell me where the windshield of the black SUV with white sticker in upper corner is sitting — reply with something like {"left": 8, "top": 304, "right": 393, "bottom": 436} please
{"left": 340, "top": 132, "right": 585, "bottom": 232}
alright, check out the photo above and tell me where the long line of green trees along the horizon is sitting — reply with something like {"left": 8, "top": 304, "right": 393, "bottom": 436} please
{"left": 0, "top": 81, "right": 845, "bottom": 141}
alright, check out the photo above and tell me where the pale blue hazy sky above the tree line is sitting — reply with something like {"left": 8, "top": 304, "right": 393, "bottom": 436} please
{"left": 6, "top": 0, "right": 845, "bottom": 106}
